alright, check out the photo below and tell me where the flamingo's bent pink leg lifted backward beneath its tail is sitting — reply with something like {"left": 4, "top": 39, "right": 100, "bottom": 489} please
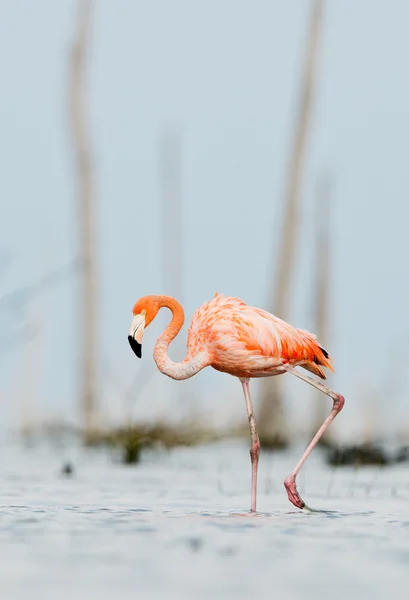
{"left": 284, "top": 365, "right": 345, "bottom": 508}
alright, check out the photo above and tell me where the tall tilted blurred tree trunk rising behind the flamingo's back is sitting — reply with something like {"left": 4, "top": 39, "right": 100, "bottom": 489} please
{"left": 260, "top": 0, "right": 323, "bottom": 448}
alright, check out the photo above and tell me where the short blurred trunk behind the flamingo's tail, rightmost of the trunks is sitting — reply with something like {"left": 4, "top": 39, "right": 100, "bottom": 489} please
{"left": 312, "top": 176, "right": 332, "bottom": 446}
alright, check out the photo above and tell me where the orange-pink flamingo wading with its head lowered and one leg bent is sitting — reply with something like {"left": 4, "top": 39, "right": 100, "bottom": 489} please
{"left": 128, "top": 293, "right": 344, "bottom": 513}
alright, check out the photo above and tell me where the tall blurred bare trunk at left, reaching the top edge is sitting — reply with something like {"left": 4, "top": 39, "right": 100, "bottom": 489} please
{"left": 68, "top": 0, "right": 97, "bottom": 439}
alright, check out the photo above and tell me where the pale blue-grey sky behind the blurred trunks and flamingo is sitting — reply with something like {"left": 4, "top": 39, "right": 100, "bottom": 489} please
{"left": 0, "top": 0, "right": 409, "bottom": 440}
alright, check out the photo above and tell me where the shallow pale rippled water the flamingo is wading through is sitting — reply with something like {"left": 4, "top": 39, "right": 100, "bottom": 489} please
{"left": 0, "top": 444, "right": 409, "bottom": 600}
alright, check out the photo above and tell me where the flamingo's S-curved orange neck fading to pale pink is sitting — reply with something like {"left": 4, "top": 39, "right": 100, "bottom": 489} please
{"left": 153, "top": 296, "right": 209, "bottom": 380}
